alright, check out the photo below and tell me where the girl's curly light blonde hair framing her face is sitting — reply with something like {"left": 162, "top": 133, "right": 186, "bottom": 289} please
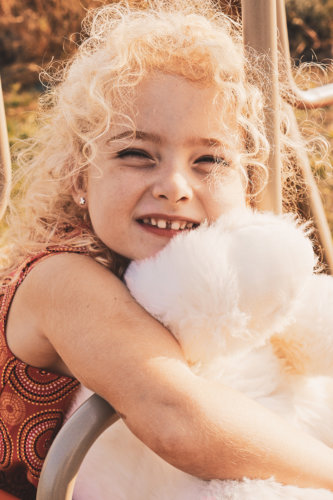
{"left": 1, "top": 0, "right": 308, "bottom": 277}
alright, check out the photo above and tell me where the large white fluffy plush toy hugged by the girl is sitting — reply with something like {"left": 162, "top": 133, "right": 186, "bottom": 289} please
{"left": 75, "top": 210, "right": 333, "bottom": 500}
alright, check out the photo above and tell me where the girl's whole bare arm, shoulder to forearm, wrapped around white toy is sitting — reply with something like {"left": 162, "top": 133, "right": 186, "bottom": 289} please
{"left": 7, "top": 254, "right": 333, "bottom": 490}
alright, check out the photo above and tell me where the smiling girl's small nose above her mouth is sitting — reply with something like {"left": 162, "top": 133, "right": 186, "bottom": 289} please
{"left": 152, "top": 172, "right": 193, "bottom": 203}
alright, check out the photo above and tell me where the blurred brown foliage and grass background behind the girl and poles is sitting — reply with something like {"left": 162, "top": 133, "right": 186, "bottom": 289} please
{"left": 0, "top": 0, "right": 333, "bottom": 227}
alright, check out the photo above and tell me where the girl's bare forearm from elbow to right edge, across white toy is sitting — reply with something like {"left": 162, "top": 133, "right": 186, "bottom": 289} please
{"left": 126, "top": 378, "right": 333, "bottom": 490}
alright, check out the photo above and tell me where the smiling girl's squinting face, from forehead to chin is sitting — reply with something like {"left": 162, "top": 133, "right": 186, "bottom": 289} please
{"left": 84, "top": 74, "right": 245, "bottom": 259}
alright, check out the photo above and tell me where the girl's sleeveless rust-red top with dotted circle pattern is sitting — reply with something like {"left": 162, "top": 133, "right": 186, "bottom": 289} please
{"left": 0, "top": 247, "right": 84, "bottom": 500}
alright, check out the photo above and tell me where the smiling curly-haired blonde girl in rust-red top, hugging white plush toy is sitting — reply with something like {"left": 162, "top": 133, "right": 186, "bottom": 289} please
{"left": 0, "top": 0, "right": 333, "bottom": 499}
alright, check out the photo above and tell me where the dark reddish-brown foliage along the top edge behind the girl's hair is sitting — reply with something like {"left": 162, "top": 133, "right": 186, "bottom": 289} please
{"left": 0, "top": 0, "right": 333, "bottom": 71}
